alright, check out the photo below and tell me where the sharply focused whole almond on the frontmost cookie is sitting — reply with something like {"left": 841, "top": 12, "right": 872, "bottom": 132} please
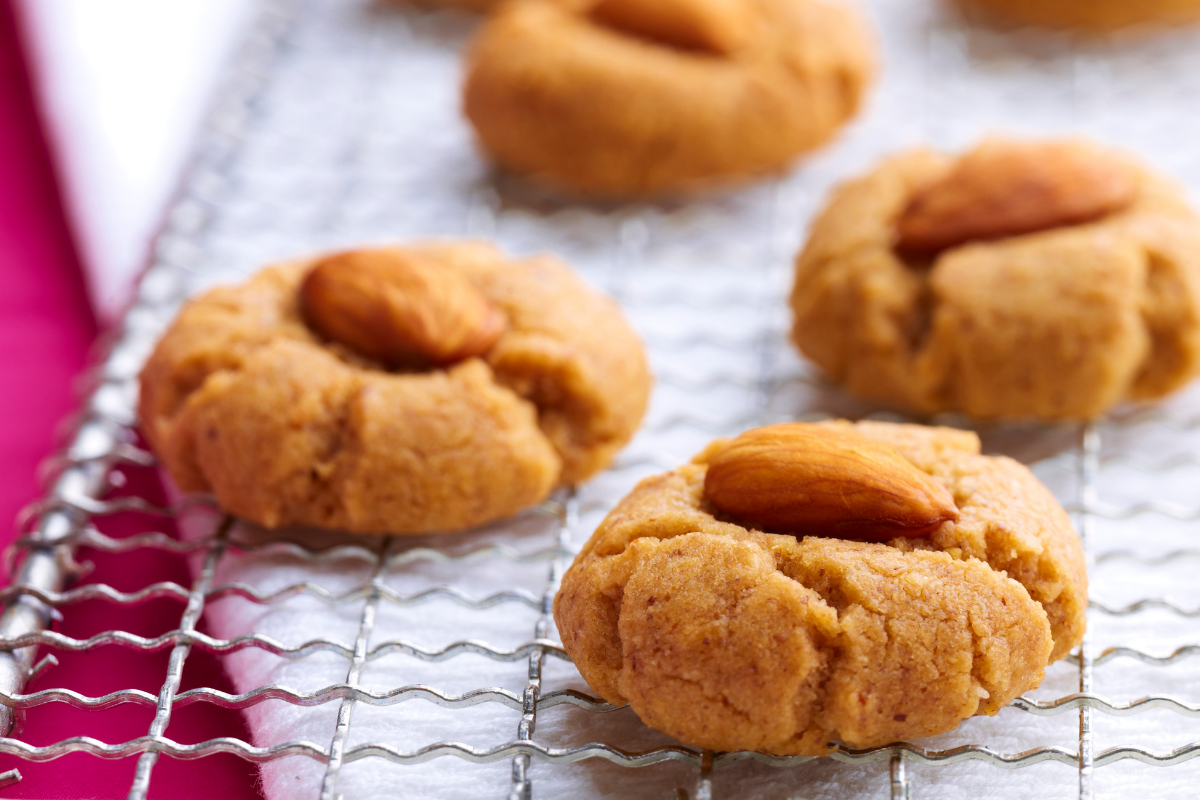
{"left": 704, "top": 422, "right": 959, "bottom": 542}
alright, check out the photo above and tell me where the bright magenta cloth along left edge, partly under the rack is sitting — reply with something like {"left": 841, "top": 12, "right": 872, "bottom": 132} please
{"left": 0, "top": 0, "right": 260, "bottom": 800}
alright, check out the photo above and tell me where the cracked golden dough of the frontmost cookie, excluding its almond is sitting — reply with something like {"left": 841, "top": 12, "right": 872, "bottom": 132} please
{"left": 554, "top": 422, "right": 1087, "bottom": 756}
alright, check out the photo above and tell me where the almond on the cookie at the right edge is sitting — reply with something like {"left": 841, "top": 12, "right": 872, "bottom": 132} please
{"left": 896, "top": 139, "right": 1136, "bottom": 254}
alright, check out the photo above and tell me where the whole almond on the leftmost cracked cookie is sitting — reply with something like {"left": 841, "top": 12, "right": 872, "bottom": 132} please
{"left": 300, "top": 249, "right": 506, "bottom": 368}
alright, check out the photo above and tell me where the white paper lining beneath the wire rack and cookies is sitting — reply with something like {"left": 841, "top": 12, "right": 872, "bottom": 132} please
{"left": 164, "top": 0, "right": 1200, "bottom": 800}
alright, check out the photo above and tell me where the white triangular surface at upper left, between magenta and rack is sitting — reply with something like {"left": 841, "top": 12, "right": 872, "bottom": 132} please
{"left": 17, "top": 0, "right": 252, "bottom": 324}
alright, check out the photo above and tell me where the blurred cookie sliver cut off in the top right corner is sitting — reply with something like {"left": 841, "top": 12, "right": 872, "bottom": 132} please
{"left": 959, "top": 0, "right": 1200, "bottom": 31}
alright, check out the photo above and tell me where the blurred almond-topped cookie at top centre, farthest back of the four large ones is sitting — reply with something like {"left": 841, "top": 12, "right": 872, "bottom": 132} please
{"left": 463, "top": 0, "right": 872, "bottom": 196}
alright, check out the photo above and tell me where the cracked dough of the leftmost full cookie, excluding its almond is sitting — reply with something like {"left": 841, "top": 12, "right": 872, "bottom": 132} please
{"left": 138, "top": 242, "right": 650, "bottom": 534}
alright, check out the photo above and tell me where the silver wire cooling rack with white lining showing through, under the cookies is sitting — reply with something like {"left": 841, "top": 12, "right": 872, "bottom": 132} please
{"left": 0, "top": 0, "right": 1200, "bottom": 800}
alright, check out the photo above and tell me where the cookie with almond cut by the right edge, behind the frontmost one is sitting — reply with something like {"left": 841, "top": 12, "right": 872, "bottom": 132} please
{"left": 791, "top": 139, "right": 1200, "bottom": 420}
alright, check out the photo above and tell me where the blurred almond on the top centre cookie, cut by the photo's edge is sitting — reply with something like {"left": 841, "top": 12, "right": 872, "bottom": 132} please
{"left": 590, "top": 0, "right": 754, "bottom": 55}
